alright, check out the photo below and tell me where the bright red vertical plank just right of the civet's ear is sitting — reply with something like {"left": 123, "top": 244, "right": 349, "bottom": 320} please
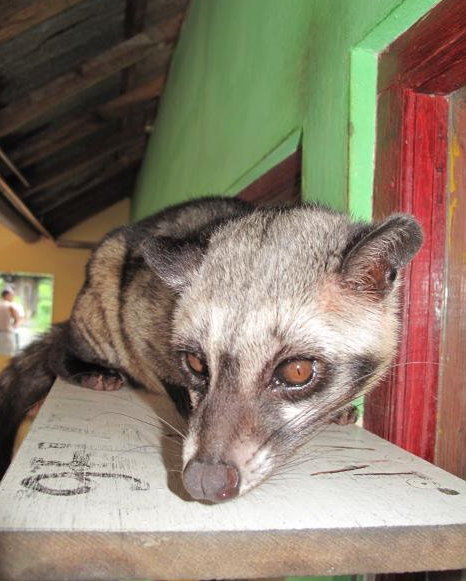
{"left": 399, "top": 94, "right": 448, "bottom": 461}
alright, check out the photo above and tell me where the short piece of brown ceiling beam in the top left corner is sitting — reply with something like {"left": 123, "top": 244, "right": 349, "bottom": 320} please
{"left": 0, "top": 0, "right": 82, "bottom": 42}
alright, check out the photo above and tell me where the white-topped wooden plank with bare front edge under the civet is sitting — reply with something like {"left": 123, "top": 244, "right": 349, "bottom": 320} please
{"left": 0, "top": 381, "right": 466, "bottom": 581}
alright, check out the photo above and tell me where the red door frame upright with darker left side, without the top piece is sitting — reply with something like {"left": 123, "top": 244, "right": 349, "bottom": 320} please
{"left": 364, "top": 89, "right": 448, "bottom": 460}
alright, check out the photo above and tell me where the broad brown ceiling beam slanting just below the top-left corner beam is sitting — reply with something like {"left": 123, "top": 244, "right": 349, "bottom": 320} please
{"left": 0, "top": 34, "right": 154, "bottom": 137}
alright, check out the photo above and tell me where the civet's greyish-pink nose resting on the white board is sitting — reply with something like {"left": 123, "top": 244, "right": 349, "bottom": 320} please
{"left": 183, "top": 459, "right": 240, "bottom": 502}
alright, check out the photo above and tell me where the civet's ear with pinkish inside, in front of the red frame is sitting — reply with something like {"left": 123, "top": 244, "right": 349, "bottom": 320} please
{"left": 341, "top": 214, "right": 422, "bottom": 300}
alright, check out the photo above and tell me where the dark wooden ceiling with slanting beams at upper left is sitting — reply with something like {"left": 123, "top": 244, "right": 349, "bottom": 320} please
{"left": 0, "top": 0, "right": 188, "bottom": 241}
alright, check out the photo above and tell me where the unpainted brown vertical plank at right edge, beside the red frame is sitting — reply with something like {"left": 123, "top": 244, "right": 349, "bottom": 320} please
{"left": 435, "top": 89, "right": 466, "bottom": 478}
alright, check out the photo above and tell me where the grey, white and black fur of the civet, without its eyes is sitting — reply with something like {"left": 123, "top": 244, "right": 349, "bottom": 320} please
{"left": 0, "top": 198, "right": 422, "bottom": 501}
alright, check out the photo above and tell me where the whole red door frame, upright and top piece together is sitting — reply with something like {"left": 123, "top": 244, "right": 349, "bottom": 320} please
{"left": 364, "top": 0, "right": 466, "bottom": 461}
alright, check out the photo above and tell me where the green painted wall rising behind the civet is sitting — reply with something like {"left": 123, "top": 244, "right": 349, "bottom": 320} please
{"left": 133, "top": 0, "right": 438, "bottom": 219}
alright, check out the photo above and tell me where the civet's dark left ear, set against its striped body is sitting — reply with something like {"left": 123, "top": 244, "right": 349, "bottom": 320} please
{"left": 141, "top": 236, "right": 206, "bottom": 292}
